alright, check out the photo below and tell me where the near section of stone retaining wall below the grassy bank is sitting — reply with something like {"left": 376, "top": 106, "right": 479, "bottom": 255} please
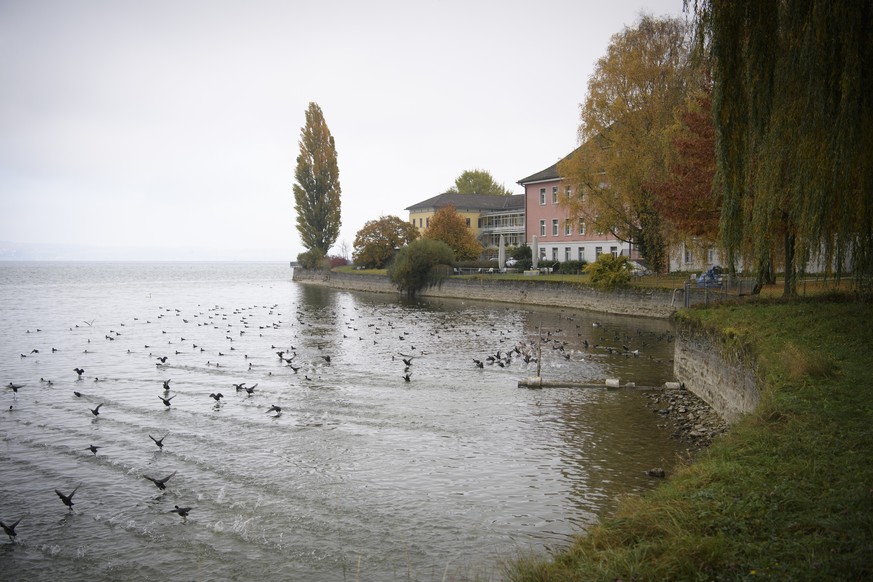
{"left": 673, "top": 321, "right": 760, "bottom": 423}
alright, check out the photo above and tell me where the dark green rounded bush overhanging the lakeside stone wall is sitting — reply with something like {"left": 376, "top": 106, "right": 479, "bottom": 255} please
{"left": 388, "top": 238, "right": 455, "bottom": 296}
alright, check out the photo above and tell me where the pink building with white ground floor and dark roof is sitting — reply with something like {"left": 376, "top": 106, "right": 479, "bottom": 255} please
{"left": 518, "top": 153, "right": 638, "bottom": 266}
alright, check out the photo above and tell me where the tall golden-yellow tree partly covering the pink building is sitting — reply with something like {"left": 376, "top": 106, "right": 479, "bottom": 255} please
{"left": 558, "top": 16, "right": 695, "bottom": 271}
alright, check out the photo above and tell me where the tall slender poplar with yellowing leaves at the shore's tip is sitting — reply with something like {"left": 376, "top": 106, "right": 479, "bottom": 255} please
{"left": 293, "top": 103, "right": 342, "bottom": 255}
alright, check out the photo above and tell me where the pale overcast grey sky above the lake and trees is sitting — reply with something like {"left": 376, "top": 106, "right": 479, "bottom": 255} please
{"left": 0, "top": 0, "right": 682, "bottom": 260}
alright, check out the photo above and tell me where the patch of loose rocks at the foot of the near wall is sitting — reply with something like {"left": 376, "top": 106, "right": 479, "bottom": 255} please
{"left": 647, "top": 387, "right": 727, "bottom": 451}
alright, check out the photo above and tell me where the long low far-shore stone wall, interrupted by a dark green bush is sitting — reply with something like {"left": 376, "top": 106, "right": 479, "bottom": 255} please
{"left": 294, "top": 269, "right": 682, "bottom": 318}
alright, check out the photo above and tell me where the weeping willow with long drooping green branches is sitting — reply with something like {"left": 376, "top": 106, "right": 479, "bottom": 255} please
{"left": 695, "top": 0, "right": 873, "bottom": 297}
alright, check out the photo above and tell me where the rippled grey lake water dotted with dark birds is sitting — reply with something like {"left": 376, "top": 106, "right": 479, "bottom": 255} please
{"left": 0, "top": 263, "right": 680, "bottom": 582}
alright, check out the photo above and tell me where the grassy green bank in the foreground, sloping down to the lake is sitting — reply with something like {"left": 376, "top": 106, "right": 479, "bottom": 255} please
{"left": 510, "top": 298, "right": 873, "bottom": 582}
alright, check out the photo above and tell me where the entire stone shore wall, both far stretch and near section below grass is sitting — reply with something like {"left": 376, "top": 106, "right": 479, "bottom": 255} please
{"left": 293, "top": 269, "right": 760, "bottom": 424}
